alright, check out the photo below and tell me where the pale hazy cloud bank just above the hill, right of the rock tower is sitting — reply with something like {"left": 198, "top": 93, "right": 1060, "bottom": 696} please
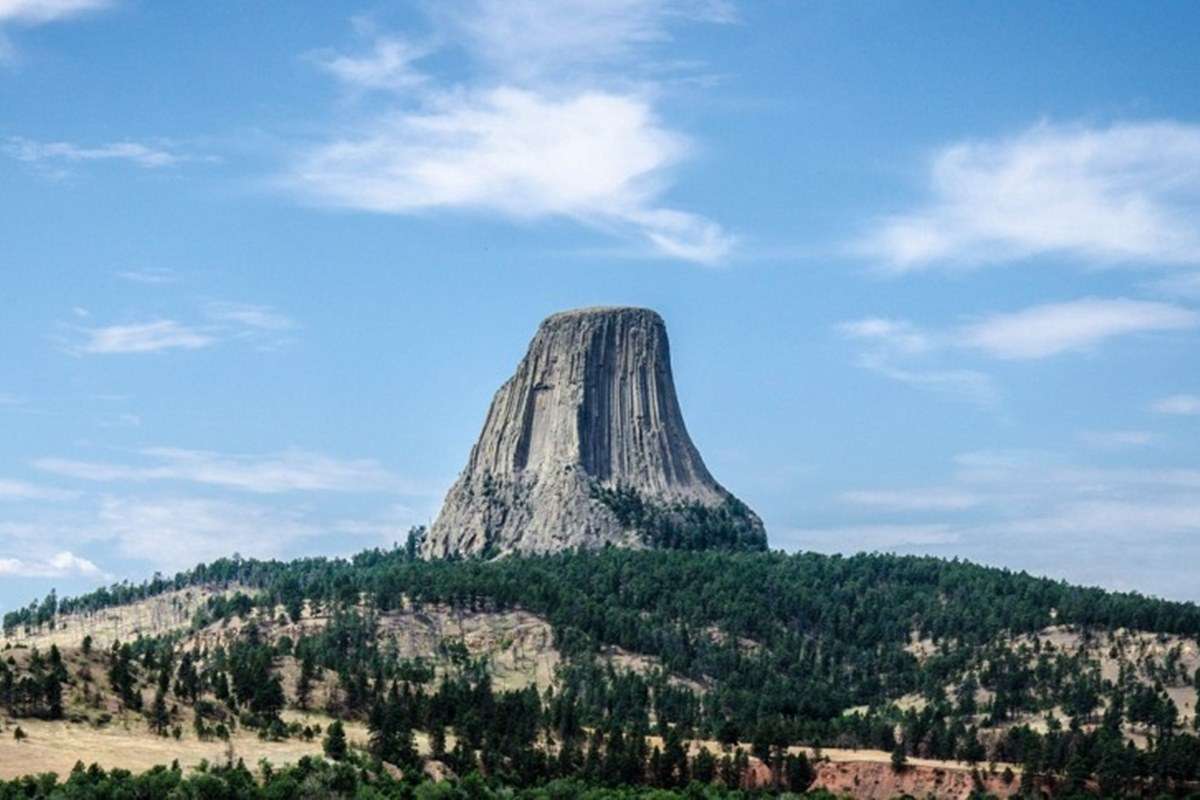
{"left": 776, "top": 450, "right": 1200, "bottom": 601}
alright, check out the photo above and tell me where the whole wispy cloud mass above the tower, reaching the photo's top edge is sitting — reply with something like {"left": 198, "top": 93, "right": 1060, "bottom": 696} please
{"left": 282, "top": 0, "right": 733, "bottom": 263}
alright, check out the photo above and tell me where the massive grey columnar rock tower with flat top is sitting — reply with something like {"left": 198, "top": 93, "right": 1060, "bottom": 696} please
{"left": 422, "top": 303, "right": 766, "bottom": 558}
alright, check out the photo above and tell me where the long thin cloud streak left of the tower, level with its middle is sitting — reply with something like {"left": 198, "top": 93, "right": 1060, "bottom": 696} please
{"left": 34, "top": 447, "right": 410, "bottom": 494}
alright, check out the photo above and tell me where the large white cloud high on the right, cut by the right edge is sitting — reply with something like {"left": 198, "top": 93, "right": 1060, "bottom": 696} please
{"left": 854, "top": 121, "right": 1200, "bottom": 271}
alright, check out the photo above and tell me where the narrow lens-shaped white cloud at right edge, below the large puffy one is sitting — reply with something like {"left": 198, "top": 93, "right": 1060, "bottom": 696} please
{"left": 955, "top": 297, "right": 1200, "bottom": 359}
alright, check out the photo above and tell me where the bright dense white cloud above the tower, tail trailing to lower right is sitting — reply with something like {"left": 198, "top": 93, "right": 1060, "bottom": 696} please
{"left": 289, "top": 88, "right": 733, "bottom": 263}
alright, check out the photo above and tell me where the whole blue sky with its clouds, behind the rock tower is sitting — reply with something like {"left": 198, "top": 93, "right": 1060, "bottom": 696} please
{"left": 0, "top": 0, "right": 1200, "bottom": 607}
